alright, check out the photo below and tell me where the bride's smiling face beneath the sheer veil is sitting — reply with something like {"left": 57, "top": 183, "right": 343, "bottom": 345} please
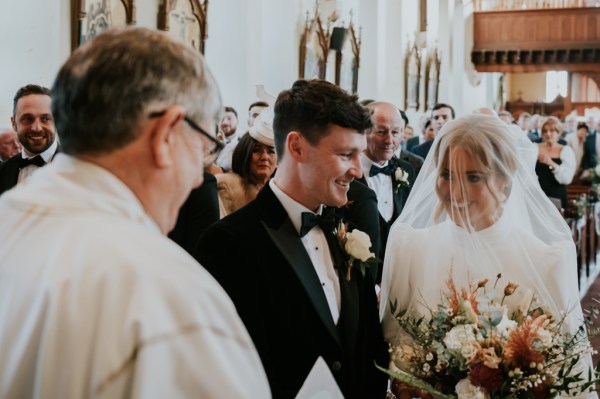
{"left": 436, "top": 148, "right": 502, "bottom": 231}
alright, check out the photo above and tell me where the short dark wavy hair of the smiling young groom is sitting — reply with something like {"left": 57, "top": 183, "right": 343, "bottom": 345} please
{"left": 273, "top": 79, "right": 372, "bottom": 159}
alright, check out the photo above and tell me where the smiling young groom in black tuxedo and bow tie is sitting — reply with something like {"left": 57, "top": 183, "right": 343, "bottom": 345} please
{"left": 196, "top": 80, "right": 388, "bottom": 398}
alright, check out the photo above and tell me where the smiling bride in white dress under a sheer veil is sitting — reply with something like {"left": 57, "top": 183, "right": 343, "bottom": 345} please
{"left": 380, "top": 115, "right": 597, "bottom": 398}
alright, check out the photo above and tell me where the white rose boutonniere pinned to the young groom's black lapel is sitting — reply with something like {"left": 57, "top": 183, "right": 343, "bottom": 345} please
{"left": 335, "top": 222, "right": 381, "bottom": 281}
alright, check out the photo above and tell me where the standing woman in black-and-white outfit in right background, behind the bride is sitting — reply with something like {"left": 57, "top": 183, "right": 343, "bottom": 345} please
{"left": 535, "top": 116, "right": 576, "bottom": 208}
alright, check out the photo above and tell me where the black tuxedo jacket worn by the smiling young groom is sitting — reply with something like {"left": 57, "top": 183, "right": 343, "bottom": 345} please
{"left": 196, "top": 185, "right": 388, "bottom": 398}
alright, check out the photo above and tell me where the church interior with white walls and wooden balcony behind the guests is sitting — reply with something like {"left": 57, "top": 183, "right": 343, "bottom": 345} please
{"left": 0, "top": 0, "right": 600, "bottom": 390}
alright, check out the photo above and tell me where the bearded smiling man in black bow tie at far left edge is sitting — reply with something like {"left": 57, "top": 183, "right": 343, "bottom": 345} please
{"left": 0, "top": 84, "right": 60, "bottom": 194}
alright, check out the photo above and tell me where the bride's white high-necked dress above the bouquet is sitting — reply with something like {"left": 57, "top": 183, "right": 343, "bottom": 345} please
{"left": 380, "top": 217, "right": 582, "bottom": 343}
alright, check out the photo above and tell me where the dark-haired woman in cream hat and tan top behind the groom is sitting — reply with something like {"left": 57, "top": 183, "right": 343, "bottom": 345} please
{"left": 216, "top": 108, "right": 277, "bottom": 218}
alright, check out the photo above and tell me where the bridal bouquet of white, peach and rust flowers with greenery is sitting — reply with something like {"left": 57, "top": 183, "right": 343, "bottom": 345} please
{"left": 382, "top": 275, "right": 598, "bottom": 399}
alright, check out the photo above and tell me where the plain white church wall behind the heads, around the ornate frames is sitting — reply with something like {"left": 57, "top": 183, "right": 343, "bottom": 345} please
{"left": 0, "top": 0, "right": 493, "bottom": 128}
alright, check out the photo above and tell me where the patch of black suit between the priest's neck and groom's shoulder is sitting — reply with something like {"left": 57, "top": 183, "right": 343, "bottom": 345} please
{"left": 169, "top": 172, "right": 220, "bottom": 254}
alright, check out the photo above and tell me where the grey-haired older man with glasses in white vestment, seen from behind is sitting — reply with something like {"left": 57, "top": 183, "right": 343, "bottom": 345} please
{"left": 0, "top": 29, "right": 270, "bottom": 398}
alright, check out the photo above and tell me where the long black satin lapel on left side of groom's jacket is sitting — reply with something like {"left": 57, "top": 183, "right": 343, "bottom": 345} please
{"left": 257, "top": 185, "right": 342, "bottom": 346}
